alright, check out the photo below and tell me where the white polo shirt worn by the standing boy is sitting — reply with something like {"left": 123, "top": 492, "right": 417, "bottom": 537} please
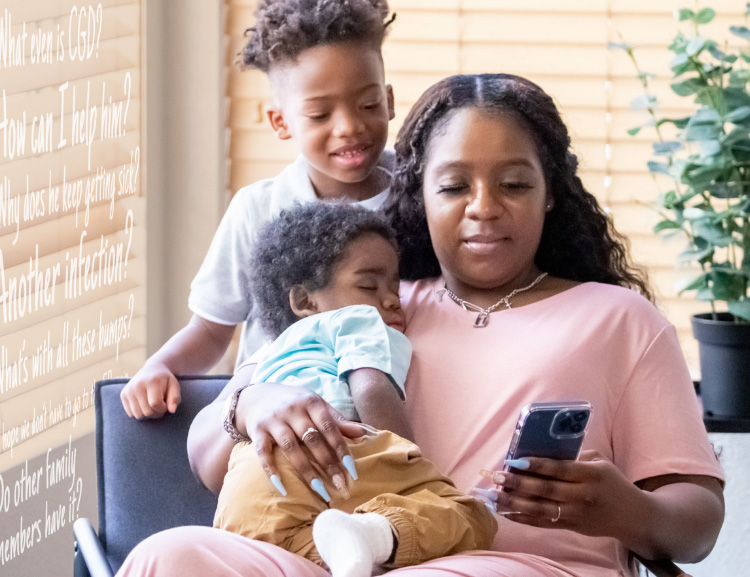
{"left": 188, "top": 151, "right": 394, "bottom": 363}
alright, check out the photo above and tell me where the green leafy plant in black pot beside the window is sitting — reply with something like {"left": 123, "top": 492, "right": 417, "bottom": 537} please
{"left": 613, "top": 3, "right": 750, "bottom": 419}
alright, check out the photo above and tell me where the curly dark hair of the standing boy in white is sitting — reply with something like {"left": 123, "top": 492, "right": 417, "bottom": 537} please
{"left": 237, "top": 0, "right": 395, "bottom": 72}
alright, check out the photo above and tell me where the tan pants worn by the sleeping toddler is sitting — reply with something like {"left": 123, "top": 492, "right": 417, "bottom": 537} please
{"left": 214, "top": 430, "right": 497, "bottom": 567}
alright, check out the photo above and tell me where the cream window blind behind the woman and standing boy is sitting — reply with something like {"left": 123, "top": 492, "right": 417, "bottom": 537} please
{"left": 227, "top": 0, "right": 745, "bottom": 369}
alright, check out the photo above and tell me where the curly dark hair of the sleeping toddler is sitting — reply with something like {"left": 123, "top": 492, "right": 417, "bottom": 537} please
{"left": 249, "top": 202, "right": 396, "bottom": 338}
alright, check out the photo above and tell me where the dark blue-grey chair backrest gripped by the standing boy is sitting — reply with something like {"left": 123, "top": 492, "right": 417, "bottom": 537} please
{"left": 95, "top": 375, "right": 229, "bottom": 572}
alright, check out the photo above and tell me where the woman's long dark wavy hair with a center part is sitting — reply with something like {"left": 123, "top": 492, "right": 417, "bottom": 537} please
{"left": 385, "top": 74, "right": 654, "bottom": 300}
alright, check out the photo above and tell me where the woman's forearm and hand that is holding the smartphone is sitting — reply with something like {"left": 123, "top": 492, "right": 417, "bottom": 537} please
{"left": 482, "top": 451, "right": 724, "bottom": 563}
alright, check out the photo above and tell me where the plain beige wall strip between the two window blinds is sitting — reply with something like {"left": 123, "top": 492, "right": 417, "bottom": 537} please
{"left": 146, "top": 0, "right": 227, "bottom": 354}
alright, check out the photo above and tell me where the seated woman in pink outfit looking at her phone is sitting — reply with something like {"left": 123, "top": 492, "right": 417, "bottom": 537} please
{"left": 116, "top": 75, "right": 723, "bottom": 577}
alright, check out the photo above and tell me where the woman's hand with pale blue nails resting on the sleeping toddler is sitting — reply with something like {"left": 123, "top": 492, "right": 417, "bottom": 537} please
{"left": 236, "top": 383, "right": 363, "bottom": 498}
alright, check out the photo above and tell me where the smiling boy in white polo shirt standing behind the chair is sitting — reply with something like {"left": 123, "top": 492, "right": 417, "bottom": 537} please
{"left": 121, "top": 0, "right": 394, "bottom": 418}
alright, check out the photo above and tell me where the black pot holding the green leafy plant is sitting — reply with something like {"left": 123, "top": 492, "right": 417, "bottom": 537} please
{"left": 693, "top": 313, "right": 750, "bottom": 419}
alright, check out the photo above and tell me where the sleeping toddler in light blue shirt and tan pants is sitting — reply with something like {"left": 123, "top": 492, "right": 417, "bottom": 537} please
{"left": 214, "top": 203, "right": 497, "bottom": 577}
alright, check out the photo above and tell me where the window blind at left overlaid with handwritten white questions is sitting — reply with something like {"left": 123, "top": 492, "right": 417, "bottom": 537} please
{"left": 0, "top": 0, "right": 146, "bottom": 468}
